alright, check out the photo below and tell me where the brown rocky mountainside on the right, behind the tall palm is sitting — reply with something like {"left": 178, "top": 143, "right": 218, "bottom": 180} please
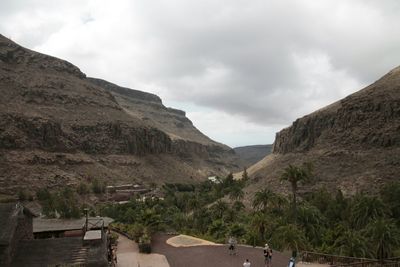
{"left": 248, "top": 67, "right": 400, "bottom": 197}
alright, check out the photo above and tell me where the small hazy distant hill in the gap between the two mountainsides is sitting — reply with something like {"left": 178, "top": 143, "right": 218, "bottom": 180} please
{"left": 233, "top": 145, "right": 272, "bottom": 167}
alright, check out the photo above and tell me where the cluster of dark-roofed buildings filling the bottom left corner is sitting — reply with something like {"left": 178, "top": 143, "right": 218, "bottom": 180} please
{"left": 0, "top": 203, "right": 112, "bottom": 267}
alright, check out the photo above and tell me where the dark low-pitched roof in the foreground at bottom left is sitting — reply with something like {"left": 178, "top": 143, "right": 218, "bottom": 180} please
{"left": 11, "top": 237, "right": 107, "bottom": 267}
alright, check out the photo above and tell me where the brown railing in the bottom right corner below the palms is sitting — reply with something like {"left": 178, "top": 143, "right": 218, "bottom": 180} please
{"left": 300, "top": 251, "right": 400, "bottom": 267}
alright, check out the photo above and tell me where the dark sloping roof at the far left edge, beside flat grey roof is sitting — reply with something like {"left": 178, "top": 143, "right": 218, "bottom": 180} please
{"left": 0, "top": 203, "right": 22, "bottom": 245}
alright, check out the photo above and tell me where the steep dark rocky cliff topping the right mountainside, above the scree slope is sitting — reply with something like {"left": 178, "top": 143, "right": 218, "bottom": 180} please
{"left": 274, "top": 68, "right": 400, "bottom": 154}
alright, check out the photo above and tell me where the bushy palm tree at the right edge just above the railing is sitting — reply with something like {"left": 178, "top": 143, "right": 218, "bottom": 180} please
{"left": 365, "top": 218, "right": 400, "bottom": 260}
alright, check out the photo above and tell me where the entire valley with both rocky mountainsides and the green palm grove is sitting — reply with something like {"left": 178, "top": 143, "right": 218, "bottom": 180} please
{"left": 0, "top": 35, "right": 400, "bottom": 264}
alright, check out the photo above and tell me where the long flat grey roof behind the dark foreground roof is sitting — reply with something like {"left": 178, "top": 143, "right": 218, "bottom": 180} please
{"left": 33, "top": 217, "right": 114, "bottom": 233}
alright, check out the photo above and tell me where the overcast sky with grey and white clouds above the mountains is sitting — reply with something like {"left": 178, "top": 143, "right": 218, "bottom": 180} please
{"left": 0, "top": 0, "right": 400, "bottom": 146}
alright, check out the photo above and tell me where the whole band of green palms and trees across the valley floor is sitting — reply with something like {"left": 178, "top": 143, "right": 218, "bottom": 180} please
{"left": 100, "top": 172, "right": 400, "bottom": 259}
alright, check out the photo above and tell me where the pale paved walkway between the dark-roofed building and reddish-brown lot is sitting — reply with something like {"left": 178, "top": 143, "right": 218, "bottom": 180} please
{"left": 117, "top": 235, "right": 170, "bottom": 267}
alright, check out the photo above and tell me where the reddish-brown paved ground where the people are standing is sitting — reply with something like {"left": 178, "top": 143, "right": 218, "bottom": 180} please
{"left": 152, "top": 234, "right": 289, "bottom": 267}
